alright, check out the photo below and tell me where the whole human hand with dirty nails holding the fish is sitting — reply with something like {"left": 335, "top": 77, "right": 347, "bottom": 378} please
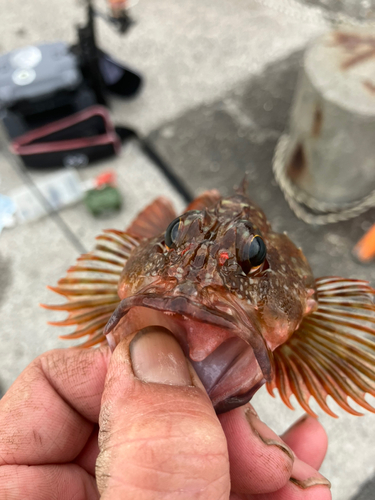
{"left": 0, "top": 332, "right": 331, "bottom": 500}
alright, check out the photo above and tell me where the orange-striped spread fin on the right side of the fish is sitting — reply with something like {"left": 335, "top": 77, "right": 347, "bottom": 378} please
{"left": 267, "top": 276, "right": 375, "bottom": 417}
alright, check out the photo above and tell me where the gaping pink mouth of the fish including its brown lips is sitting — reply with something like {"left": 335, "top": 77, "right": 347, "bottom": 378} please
{"left": 104, "top": 294, "right": 272, "bottom": 413}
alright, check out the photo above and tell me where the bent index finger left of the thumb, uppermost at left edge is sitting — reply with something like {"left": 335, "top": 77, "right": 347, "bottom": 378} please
{"left": 0, "top": 348, "right": 110, "bottom": 466}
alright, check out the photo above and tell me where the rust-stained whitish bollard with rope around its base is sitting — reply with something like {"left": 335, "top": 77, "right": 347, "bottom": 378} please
{"left": 284, "top": 27, "right": 375, "bottom": 207}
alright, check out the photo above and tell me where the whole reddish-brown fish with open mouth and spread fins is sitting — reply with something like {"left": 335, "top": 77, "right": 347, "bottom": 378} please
{"left": 44, "top": 185, "right": 375, "bottom": 416}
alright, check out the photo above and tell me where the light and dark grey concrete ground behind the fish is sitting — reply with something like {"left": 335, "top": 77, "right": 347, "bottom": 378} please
{"left": 0, "top": 0, "right": 375, "bottom": 500}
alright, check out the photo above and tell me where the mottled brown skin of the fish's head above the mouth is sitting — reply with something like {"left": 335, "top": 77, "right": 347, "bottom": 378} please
{"left": 118, "top": 193, "right": 316, "bottom": 351}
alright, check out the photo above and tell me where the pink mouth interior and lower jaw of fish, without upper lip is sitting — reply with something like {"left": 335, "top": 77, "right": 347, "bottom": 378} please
{"left": 107, "top": 306, "right": 264, "bottom": 413}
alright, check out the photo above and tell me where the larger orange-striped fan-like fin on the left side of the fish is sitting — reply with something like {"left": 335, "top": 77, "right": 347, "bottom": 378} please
{"left": 41, "top": 229, "right": 139, "bottom": 347}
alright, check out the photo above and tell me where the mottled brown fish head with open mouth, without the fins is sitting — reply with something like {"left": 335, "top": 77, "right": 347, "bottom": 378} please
{"left": 106, "top": 193, "right": 314, "bottom": 411}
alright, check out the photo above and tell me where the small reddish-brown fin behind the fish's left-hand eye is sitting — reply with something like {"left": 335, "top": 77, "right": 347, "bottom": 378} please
{"left": 126, "top": 196, "right": 177, "bottom": 238}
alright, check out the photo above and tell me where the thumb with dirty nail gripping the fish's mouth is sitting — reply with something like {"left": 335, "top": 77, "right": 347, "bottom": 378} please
{"left": 96, "top": 327, "right": 230, "bottom": 500}
